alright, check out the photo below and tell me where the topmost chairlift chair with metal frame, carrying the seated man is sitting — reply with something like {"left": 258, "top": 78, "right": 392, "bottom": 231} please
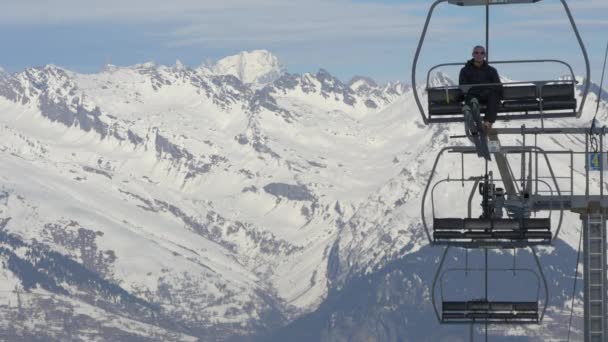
{"left": 412, "top": 0, "right": 590, "bottom": 124}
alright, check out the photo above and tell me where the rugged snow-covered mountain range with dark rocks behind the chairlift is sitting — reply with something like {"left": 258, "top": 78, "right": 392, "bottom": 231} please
{"left": 0, "top": 51, "right": 608, "bottom": 340}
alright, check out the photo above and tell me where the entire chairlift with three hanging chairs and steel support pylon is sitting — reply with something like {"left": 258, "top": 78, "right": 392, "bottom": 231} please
{"left": 412, "top": 0, "right": 608, "bottom": 341}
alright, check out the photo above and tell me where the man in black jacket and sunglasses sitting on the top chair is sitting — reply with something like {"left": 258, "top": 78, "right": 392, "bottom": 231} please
{"left": 459, "top": 45, "right": 502, "bottom": 132}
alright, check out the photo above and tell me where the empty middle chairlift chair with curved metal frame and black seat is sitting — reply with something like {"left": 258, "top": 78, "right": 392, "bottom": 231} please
{"left": 421, "top": 146, "right": 564, "bottom": 248}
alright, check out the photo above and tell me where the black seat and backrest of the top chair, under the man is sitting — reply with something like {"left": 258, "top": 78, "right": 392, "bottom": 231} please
{"left": 427, "top": 81, "right": 577, "bottom": 122}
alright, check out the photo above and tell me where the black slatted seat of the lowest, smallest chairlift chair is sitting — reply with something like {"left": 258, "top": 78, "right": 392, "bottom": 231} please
{"left": 441, "top": 300, "right": 539, "bottom": 323}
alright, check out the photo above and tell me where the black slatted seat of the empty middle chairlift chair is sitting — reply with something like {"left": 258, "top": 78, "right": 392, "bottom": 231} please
{"left": 433, "top": 218, "right": 552, "bottom": 247}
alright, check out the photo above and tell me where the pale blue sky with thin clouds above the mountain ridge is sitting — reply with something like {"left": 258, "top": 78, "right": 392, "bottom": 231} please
{"left": 0, "top": 0, "right": 608, "bottom": 83}
